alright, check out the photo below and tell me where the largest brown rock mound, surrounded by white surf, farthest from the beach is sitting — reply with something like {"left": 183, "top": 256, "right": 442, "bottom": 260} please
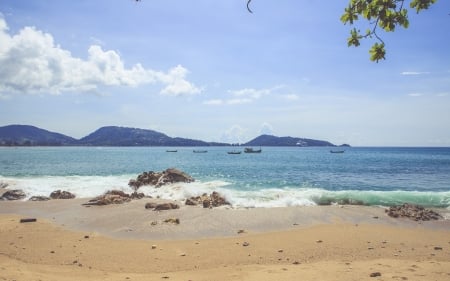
{"left": 128, "top": 168, "right": 194, "bottom": 190}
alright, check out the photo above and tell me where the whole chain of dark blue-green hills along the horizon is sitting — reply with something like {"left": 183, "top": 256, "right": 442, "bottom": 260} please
{"left": 0, "top": 125, "right": 349, "bottom": 147}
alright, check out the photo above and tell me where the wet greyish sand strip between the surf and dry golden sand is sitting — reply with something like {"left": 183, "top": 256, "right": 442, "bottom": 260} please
{"left": 0, "top": 198, "right": 450, "bottom": 240}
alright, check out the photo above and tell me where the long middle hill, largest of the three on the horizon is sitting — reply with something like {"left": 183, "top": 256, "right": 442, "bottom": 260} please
{"left": 78, "top": 126, "right": 223, "bottom": 146}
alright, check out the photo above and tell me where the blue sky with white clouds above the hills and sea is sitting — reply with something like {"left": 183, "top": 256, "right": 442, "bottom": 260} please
{"left": 0, "top": 0, "right": 450, "bottom": 146}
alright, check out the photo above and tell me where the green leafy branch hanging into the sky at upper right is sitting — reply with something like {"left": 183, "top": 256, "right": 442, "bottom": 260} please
{"left": 341, "top": 0, "right": 437, "bottom": 62}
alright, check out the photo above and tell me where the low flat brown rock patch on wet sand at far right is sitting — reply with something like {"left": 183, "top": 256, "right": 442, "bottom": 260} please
{"left": 385, "top": 203, "right": 442, "bottom": 221}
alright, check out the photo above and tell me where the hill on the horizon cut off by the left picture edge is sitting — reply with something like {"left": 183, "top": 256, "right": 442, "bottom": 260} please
{"left": 0, "top": 125, "right": 77, "bottom": 146}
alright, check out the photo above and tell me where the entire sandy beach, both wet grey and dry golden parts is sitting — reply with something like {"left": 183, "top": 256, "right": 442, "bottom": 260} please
{"left": 0, "top": 199, "right": 450, "bottom": 281}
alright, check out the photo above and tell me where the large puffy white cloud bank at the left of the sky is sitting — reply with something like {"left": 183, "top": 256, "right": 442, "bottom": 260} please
{"left": 0, "top": 17, "right": 201, "bottom": 96}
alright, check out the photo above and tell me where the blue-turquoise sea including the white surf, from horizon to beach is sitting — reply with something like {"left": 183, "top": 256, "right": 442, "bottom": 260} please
{"left": 0, "top": 147, "right": 450, "bottom": 209}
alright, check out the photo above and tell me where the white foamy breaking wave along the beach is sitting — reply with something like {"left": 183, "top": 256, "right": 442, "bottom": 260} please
{"left": 0, "top": 175, "right": 450, "bottom": 208}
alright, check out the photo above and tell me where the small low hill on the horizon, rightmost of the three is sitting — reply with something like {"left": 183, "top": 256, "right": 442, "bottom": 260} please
{"left": 244, "top": 135, "right": 336, "bottom": 146}
